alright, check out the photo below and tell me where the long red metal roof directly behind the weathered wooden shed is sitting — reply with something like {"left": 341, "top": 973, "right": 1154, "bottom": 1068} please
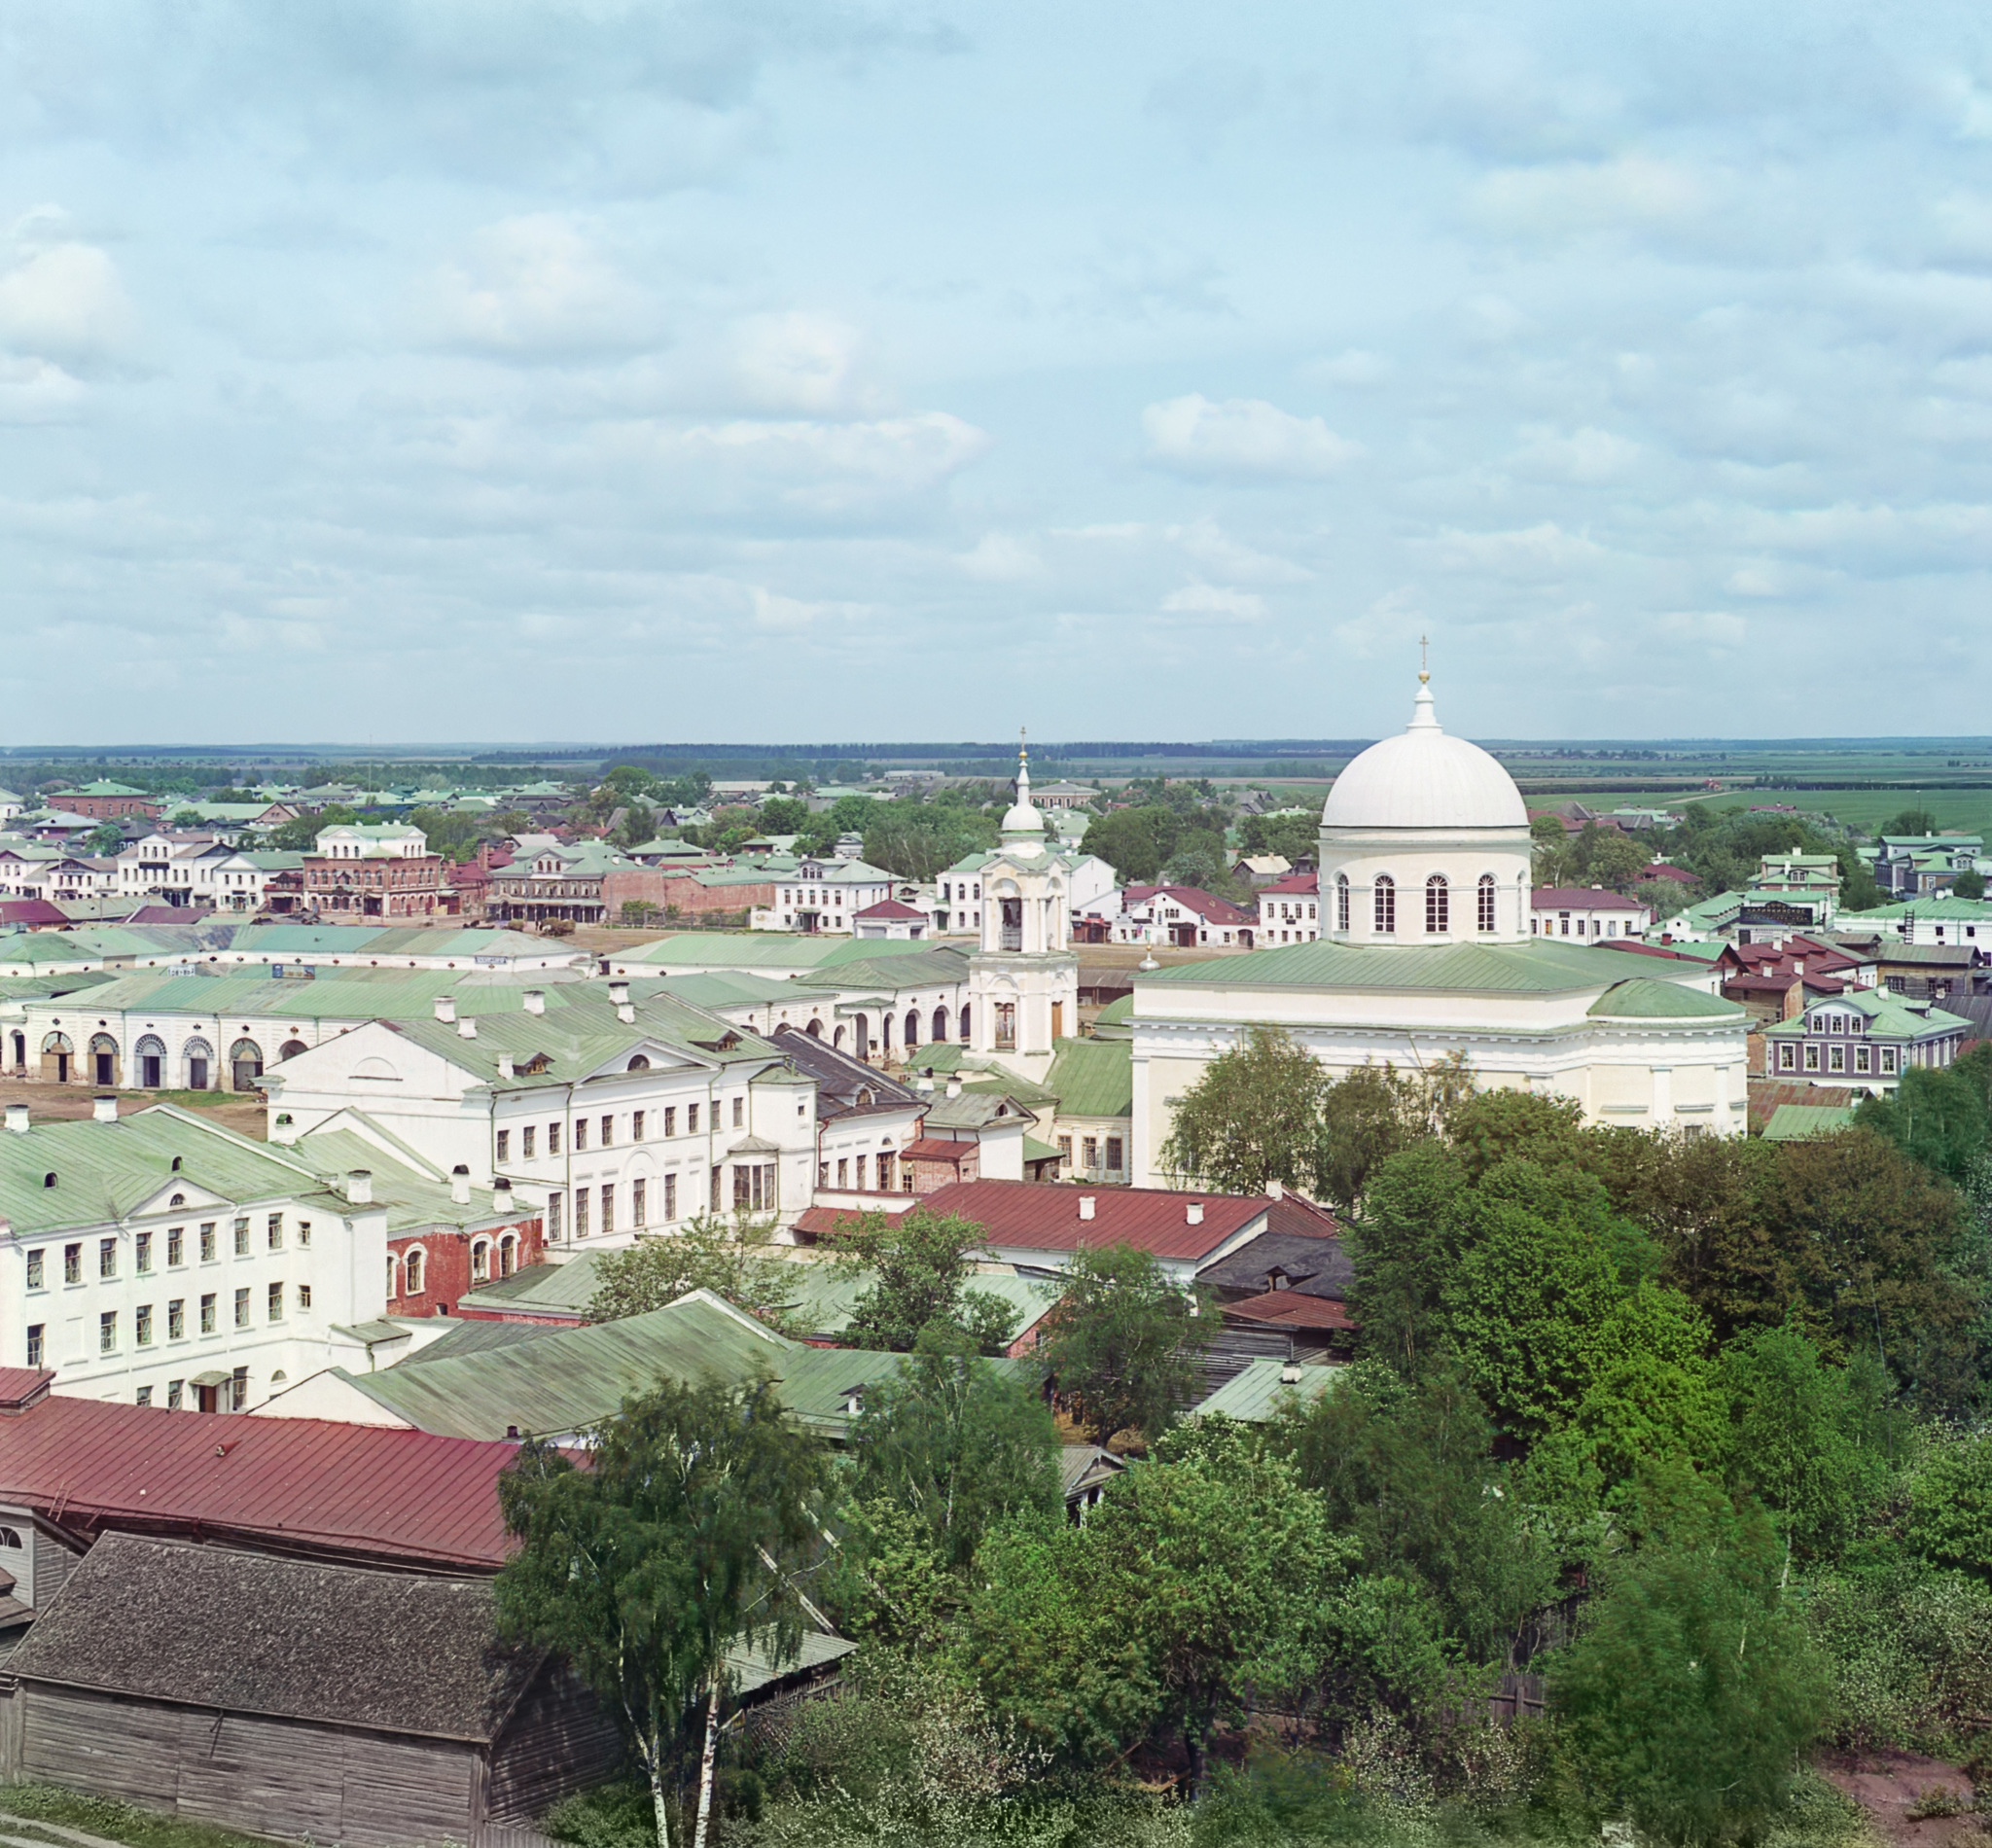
{"left": 0, "top": 1394, "right": 517, "bottom": 1571}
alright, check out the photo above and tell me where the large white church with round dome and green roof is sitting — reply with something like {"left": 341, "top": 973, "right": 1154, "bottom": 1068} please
{"left": 1131, "top": 673, "right": 1749, "bottom": 1187}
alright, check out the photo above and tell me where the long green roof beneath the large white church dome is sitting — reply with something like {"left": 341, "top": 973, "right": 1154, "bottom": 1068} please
{"left": 1133, "top": 940, "right": 1681, "bottom": 995}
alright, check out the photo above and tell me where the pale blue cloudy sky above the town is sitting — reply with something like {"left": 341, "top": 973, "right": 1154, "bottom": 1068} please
{"left": 0, "top": 0, "right": 1992, "bottom": 745}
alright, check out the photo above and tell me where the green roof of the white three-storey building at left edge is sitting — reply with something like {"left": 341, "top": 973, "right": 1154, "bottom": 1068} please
{"left": 0, "top": 1103, "right": 344, "bottom": 1238}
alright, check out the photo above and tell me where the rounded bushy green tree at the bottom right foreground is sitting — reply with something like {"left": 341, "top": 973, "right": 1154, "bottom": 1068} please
{"left": 1549, "top": 1502, "right": 1827, "bottom": 1844}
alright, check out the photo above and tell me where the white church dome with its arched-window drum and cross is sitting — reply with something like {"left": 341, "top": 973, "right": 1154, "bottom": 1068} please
{"left": 1321, "top": 675, "right": 1534, "bottom": 946}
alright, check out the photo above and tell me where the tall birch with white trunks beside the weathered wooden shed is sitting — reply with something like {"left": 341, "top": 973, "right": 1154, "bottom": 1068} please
{"left": 498, "top": 1382, "right": 823, "bottom": 1848}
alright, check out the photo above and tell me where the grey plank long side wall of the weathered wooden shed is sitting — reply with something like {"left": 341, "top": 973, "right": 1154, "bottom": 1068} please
{"left": 18, "top": 1683, "right": 480, "bottom": 1848}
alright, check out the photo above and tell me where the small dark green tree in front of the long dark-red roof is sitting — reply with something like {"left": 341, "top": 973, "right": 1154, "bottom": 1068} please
{"left": 1038, "top": 1245, "right": 1217, "bottom": 1443}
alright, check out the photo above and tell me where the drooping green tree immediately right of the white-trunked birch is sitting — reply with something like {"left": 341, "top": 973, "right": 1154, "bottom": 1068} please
{"left": 848, "top": 1333, "right": 1062, "bottom": 1573}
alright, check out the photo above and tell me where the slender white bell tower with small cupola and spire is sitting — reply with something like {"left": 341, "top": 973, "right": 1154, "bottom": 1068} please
{"left": 968, "top": 745, "right": 1080, "bottom": 1078}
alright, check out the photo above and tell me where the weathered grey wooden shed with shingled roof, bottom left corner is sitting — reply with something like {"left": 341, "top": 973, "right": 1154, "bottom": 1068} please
{"left": 0, "top": 1534, "right": 622, "bottom": 1848}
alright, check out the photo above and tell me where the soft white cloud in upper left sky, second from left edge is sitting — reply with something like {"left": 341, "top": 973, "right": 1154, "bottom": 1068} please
{"left": 424, "top": 213, "right": 658, "bottom": 359}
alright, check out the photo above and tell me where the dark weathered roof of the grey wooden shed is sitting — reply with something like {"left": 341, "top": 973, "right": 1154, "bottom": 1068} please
{"left": 8, "top": 1534, "right": 540, "bottom": 1742}
